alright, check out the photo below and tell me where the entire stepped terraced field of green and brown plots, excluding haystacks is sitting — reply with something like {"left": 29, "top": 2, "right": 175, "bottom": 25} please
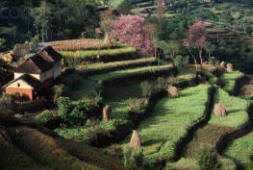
{"left": 0, "top": 37, "right": 253, "bottom": 170}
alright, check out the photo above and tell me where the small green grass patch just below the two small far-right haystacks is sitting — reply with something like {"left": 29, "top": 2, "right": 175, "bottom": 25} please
{"left": 222, "top": 71, "right": 243, "bottom": 92}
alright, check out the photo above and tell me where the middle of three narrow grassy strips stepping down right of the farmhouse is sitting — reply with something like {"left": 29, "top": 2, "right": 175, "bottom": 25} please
{"left": 80, "top": 57, "right": 156, "bottom": 75}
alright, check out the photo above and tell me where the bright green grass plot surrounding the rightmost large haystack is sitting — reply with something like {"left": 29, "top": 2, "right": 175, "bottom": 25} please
{"left": 209, "top": 89, "right": 249, "bottom": 127}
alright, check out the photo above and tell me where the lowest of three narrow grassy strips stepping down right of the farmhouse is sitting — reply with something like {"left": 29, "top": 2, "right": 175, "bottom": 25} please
{"left": 89, "top": 64, "right": 173, "bottom": 82}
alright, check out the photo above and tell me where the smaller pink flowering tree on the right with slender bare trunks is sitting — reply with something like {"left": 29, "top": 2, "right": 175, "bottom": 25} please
{"left": 186, "top": 21, "right": 207, "bottom": 65}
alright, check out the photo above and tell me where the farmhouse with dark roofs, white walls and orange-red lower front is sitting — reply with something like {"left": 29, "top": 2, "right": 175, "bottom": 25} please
{"left": 4, "top": 46, "right": 62, "bottom": 100}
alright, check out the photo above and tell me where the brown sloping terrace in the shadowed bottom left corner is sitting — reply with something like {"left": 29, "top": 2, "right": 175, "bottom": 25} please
{"left": 10, "top": 127, "right": 102, "bottom": 170}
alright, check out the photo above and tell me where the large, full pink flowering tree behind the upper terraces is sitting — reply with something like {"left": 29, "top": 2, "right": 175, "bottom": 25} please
{"left": 110, "top": 15, "right": 154, "bottom": 55}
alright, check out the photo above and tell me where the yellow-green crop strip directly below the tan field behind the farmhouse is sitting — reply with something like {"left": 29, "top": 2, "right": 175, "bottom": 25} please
{"left": 59, "top": 47, "right": 136, "bottom": 59}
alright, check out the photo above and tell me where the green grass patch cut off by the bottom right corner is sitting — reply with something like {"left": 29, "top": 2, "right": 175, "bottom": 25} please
{"left": 224, "top": 132, "right": 253, "bottom": 170}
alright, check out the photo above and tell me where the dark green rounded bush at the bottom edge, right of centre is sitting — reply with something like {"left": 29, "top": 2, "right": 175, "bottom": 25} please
{"left": 197, "top": 145, "right": 221, "bottom": 170}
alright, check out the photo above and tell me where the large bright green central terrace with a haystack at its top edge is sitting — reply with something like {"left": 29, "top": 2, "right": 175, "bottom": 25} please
{"left": 132, "top": 85, "right": 209, "bottom": 160}
